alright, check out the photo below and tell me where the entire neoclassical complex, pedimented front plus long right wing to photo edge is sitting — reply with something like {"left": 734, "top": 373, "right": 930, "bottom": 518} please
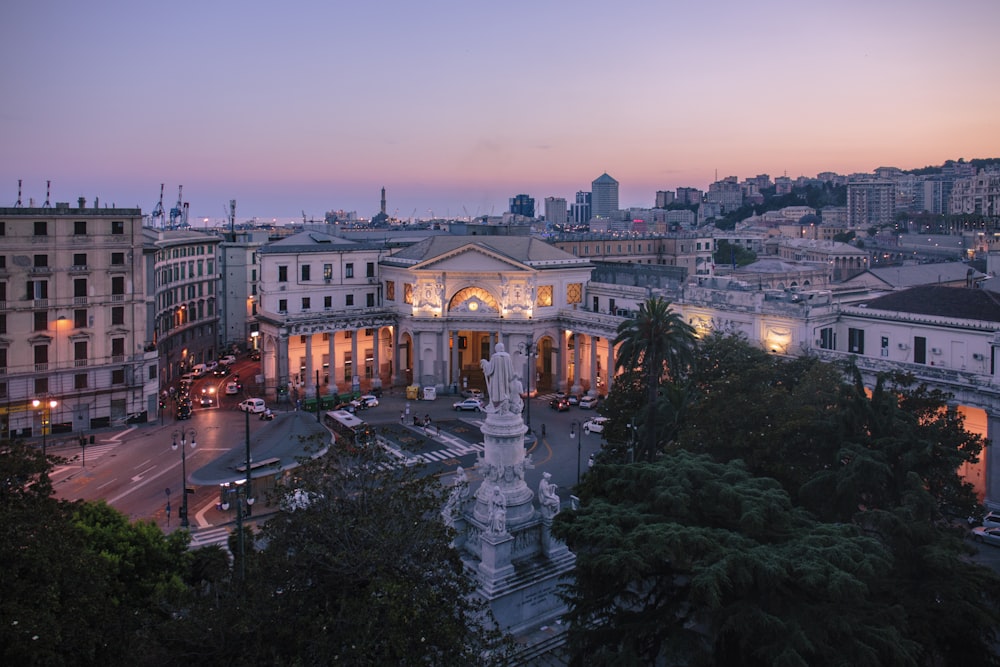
{"left": 250, "top": 232, "right": 1000, "bottom": 506}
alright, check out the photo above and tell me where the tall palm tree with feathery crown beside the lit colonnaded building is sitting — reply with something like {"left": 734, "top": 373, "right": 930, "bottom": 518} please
{"left": 615, "top": 297, "right": 695, "bottom": 460}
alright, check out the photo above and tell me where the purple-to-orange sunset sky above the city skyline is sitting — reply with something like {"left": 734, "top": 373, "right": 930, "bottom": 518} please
{"left": 0, "top": 0, "right": 1000, "bottom": 220}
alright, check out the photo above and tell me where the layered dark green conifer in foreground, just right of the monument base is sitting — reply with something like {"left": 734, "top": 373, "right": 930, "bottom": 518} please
{"left": 554, "top": 451, "right": 918, "bottom": 666}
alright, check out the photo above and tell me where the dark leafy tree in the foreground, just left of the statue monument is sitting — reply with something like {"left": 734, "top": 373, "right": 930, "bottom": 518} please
{"left": 176, "top": 440, "right": 503, "bottom": 665}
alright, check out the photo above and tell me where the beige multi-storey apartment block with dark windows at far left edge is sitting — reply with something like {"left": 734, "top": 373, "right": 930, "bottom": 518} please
{"left": 0, "top": 198, "right": 158, "bottom": 437}
